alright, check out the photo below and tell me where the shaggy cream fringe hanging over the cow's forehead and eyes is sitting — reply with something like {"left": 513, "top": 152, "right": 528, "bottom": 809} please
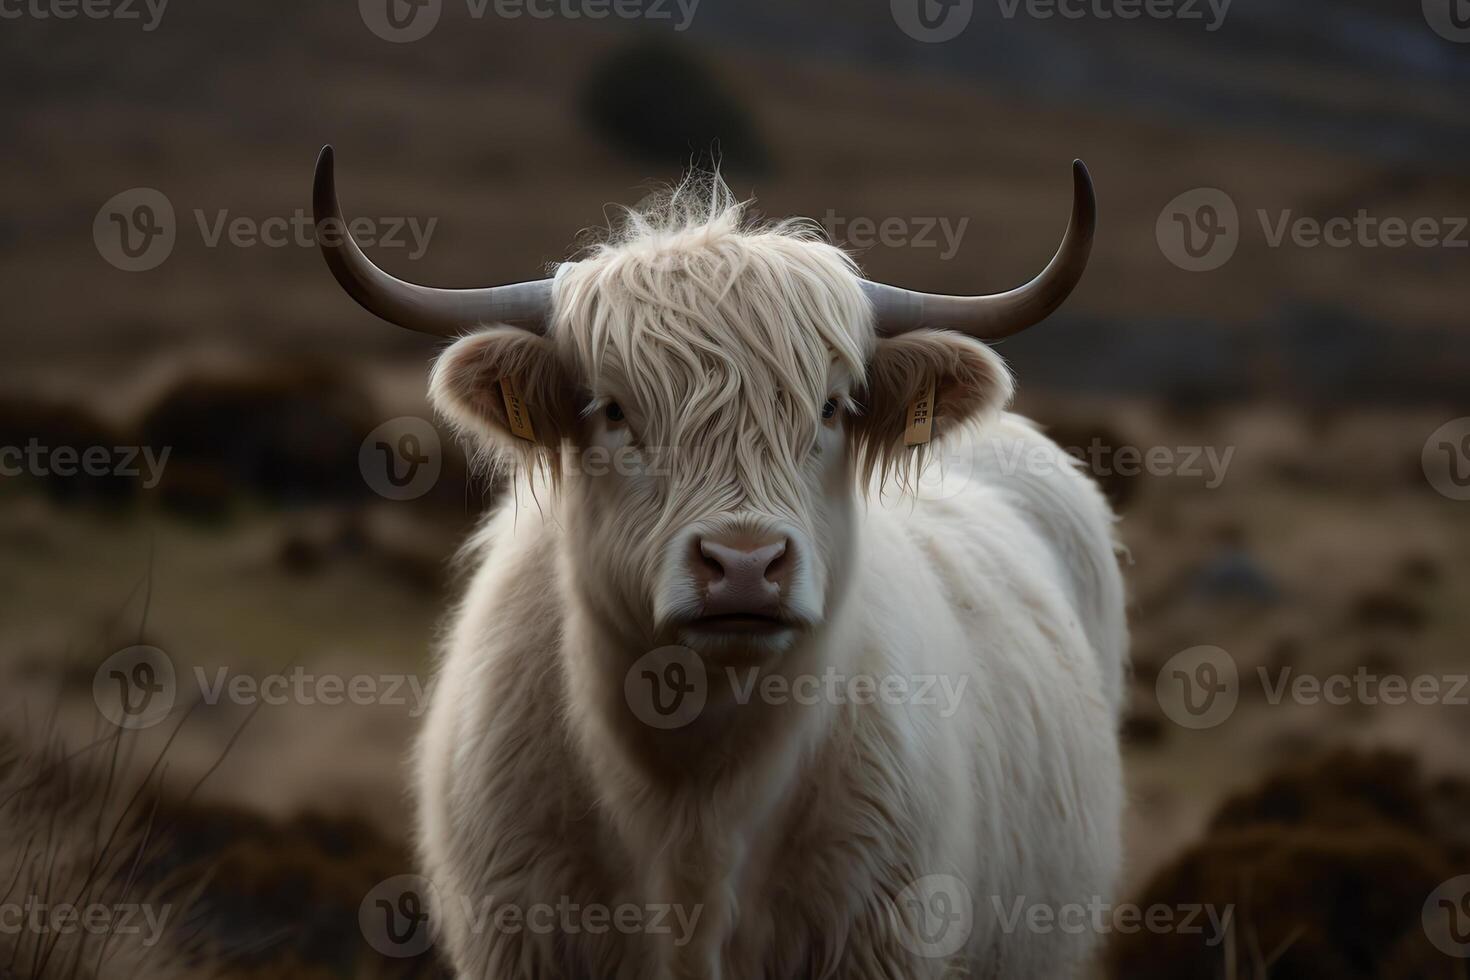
{"left": 551, "top": 175, "right": 873, "bottom": 522}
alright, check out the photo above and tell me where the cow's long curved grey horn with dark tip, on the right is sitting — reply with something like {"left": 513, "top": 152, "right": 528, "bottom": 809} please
{"left": 863, "top": 160, "right": 1097, "bottom": 341}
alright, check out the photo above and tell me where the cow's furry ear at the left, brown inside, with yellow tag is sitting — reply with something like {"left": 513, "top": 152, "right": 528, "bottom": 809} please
{"left": 429, "top": 326, "right": 581, "bottom": 455}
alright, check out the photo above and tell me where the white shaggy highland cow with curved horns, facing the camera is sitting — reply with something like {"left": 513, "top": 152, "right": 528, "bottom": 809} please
{"left": 316, "top": 148, "right": 1126, "bottom": 980}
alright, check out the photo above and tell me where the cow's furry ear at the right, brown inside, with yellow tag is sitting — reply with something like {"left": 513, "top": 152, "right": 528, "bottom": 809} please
{"left": 851, "top": 331, "right": 1013, "bottom": 475}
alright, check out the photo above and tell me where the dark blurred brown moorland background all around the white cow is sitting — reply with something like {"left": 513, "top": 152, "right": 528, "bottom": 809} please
{"left": 0, "top": 0, "right": 1470, "bottom": 977}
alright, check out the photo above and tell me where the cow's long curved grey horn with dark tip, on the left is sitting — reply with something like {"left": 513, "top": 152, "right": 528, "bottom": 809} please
{"left": 312, "top": 145, "right": 551, "bottom": 336}
